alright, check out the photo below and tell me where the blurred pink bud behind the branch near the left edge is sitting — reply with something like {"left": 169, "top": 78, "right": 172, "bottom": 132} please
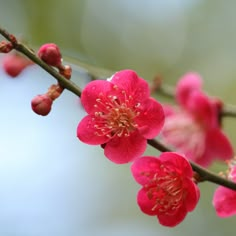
{"left": 2, "top": 54, "right": 33, "bottom": 78}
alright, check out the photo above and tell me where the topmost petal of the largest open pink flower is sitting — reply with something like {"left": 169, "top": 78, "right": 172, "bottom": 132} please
{"left": 111, "top": 70, "right": 150, "bottom": 102}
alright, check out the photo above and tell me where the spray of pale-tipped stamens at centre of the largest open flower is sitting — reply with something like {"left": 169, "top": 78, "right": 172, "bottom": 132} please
{"left": 93, "top": 91, "right": 140, "bottom": 138}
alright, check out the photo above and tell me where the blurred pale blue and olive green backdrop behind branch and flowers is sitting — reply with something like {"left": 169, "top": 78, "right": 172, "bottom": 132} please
{"left": 0, "top": 0, "right": 236, "bottom": 236}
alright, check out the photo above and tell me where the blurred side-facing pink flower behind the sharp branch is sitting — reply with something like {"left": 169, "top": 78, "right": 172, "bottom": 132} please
{"left": 162, "top": 73, "right": 233, "bottom": 166}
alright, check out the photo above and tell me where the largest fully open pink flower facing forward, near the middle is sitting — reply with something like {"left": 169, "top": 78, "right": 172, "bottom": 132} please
{"left": 77, "top": 70, "right": 164, "bottom": 164}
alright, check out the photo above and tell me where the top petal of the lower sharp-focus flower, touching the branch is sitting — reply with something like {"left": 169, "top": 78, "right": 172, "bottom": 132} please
{"left": 159, "top": 152, "right": 193, "bottom": 178}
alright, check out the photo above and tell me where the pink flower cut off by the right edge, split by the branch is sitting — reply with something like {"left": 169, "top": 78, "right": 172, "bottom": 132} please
{"left": 213, "top": 162, "right": 236, "bottom": 218}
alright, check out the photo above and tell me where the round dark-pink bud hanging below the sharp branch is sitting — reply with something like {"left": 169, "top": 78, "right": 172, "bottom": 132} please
{"left": 31, "top": 94, "right": 52, "bottom": 116}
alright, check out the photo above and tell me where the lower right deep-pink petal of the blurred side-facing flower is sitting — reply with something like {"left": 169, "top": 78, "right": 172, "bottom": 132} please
{"left": 206, "top": 129, "right": 234, "bottom": 160}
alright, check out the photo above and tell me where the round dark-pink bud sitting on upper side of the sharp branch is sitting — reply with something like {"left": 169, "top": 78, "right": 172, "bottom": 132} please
{"left": 38, "top": 43, "right": 62, "bottom": 67}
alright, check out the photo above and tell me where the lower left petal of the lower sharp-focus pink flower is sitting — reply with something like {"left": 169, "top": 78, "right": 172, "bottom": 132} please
{"left": 137, "top": 188, "right": 158, "bottom": 216}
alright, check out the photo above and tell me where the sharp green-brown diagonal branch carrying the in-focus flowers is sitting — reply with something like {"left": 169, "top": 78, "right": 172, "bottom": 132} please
{"left": 0, "top": 27, "right": 236, "bottom": 190}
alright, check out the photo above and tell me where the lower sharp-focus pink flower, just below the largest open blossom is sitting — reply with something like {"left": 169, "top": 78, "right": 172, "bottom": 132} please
{"left": 131, "top": 152, "right": 200, "bottom": 227}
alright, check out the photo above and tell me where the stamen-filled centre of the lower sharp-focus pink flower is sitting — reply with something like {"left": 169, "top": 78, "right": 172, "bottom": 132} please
{"left": 146, "top": 167, "right": 185, "bottom": 214}
